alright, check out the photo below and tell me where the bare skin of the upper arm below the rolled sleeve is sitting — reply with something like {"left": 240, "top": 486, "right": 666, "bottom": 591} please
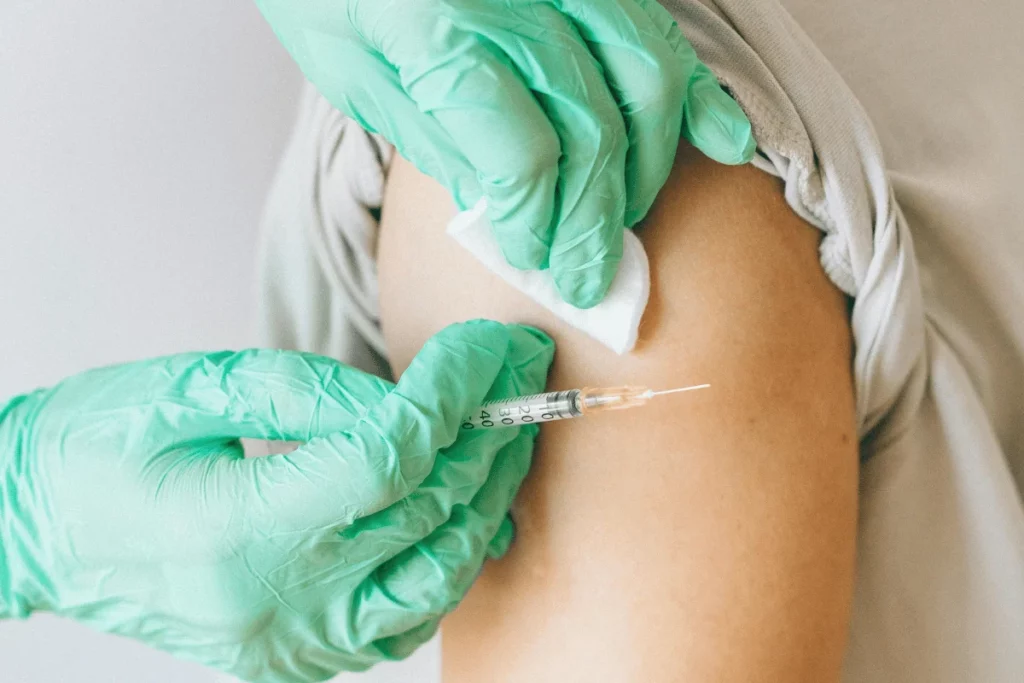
{"left": 379, "top": 144, "right": 858, "bottom": 683}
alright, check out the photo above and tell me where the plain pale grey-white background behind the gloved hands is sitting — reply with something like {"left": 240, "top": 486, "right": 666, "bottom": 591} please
{"left": 0, "top": 0, "right": 437, "bottom": 683}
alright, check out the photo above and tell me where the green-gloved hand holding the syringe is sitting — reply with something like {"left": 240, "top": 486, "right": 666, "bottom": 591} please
{"left": 0, "top": 321, "right": 553, "bottom": 682}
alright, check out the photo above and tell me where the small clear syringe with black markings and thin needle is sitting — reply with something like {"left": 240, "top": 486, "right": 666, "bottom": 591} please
{"left": 462, "top": 384, "right": 711, "bottom": 429}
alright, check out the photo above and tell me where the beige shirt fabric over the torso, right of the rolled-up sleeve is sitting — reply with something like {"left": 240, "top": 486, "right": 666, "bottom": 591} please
{"left": 782, "top": 0, "right": 1024, "bottom": 681}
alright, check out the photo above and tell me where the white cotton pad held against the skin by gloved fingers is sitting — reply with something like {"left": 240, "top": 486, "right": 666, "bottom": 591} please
{"left": 447, "top": 202, "right": 650, "bottom": 354}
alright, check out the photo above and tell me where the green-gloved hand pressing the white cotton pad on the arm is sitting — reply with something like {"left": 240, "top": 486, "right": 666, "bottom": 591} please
{"left": 256, "top": 0, "right": 755, "bottom": 308}
